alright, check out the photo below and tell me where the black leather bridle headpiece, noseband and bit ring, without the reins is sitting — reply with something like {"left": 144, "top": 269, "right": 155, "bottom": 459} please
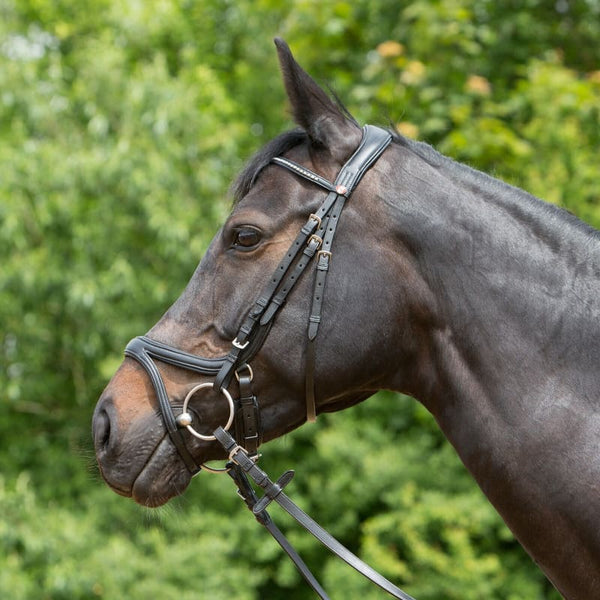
{"left": 125, "top": 125, "right": 392, "bottom": 474}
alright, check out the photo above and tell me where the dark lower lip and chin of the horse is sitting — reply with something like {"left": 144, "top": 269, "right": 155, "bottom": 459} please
{"left": 130, "top": 438, "right": 192, "bottom": 508}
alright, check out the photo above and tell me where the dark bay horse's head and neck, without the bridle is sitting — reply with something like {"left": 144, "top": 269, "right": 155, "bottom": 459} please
{"left": 93, "top": 41, "right": 600, "bottom": 600}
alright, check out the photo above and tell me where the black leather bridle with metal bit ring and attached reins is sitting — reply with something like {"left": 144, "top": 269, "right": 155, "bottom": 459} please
{"left": 125, "top": 125, "right": 413, "bottom": 600}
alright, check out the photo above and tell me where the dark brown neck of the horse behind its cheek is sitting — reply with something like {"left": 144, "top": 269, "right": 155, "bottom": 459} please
{"left": 387, "top": 143, "right": 600, "bottom": 597}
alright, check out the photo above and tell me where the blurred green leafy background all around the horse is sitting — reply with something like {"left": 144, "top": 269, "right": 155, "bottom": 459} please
{"left": 0, "top": 0, "right": 600, "bottom": 600}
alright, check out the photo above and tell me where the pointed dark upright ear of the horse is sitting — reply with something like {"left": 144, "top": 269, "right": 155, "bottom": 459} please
{"left": 275, "top": 38, "right": 362, "bottom": 162}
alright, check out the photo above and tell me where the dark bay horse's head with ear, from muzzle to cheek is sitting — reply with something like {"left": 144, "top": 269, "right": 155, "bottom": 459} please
{"left": 93, "top": 40, "right": 429, "bottom": 506}
